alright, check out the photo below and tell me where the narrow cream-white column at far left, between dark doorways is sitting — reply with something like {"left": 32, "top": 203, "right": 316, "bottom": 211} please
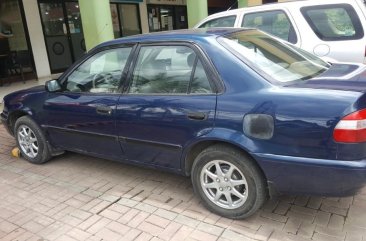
{"left": 23, "top": 0, "right": 51, "bottom": 78}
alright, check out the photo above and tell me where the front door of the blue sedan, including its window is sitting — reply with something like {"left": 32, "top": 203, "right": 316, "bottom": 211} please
{"left": 44, "top": 47, "right": 131, "bottom": 158}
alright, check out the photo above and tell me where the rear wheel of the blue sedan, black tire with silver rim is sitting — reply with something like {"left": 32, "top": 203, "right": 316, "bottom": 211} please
{"left": 191, "top": 144, "right": 268, "bottom": 219}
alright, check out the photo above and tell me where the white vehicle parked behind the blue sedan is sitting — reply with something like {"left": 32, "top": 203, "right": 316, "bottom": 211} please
{"left": 195, "top": 0, "right": 366, "bottom": 63}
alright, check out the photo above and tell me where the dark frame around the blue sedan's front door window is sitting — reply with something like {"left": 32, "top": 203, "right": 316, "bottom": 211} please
{"left": 57, "top": 43, "right": 137, "bottom": 95}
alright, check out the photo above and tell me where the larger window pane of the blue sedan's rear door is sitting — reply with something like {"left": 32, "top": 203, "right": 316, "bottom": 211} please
{"left": 129, "top": 46, "right": 196, "bottom": 94}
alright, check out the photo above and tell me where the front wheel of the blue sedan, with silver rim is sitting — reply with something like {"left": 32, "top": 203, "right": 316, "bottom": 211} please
{"left": 15, "top": 116, "right": 51, "bottom": 164}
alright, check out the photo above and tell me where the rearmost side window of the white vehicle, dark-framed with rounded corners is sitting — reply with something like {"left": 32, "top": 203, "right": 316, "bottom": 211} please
{"left": 301, "top": 4, "right": 364, "bottom": 41}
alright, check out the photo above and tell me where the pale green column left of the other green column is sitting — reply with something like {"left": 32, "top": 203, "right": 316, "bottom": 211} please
{"left": 79, "top": 0, "right": 114, "bottom": 51}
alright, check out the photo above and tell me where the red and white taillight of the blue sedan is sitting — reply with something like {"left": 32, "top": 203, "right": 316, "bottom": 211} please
{"left": 333, "top": 109, "right": 366, "bottom": 143}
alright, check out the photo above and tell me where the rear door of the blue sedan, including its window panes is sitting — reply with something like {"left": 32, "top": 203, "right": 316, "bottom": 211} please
{"left": 117, "top": 44, "right": 216, "bottom": 169}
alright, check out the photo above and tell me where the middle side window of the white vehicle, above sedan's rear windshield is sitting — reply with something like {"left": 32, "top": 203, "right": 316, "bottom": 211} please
{"left": 242, "top": 10, "right": 297, "bottom": 43}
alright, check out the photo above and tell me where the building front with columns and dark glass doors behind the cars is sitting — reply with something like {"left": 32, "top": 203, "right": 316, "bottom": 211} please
{"left": 0, "top": 0, "right": 284, "bottom": 81}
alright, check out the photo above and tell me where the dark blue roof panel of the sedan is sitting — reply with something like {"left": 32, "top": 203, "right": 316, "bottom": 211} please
{"left": 96, "top": 28, "right": 248, "bottom": 48}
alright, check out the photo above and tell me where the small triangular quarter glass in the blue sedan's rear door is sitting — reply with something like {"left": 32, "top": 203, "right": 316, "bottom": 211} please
{"left": 190, "top": 60, "right": 212, "bottom": 94}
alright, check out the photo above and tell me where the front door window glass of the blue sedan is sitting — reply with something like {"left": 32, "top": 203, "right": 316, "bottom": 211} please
{"left": 64, "top": 48, "right": 132, "bottom": 93}
